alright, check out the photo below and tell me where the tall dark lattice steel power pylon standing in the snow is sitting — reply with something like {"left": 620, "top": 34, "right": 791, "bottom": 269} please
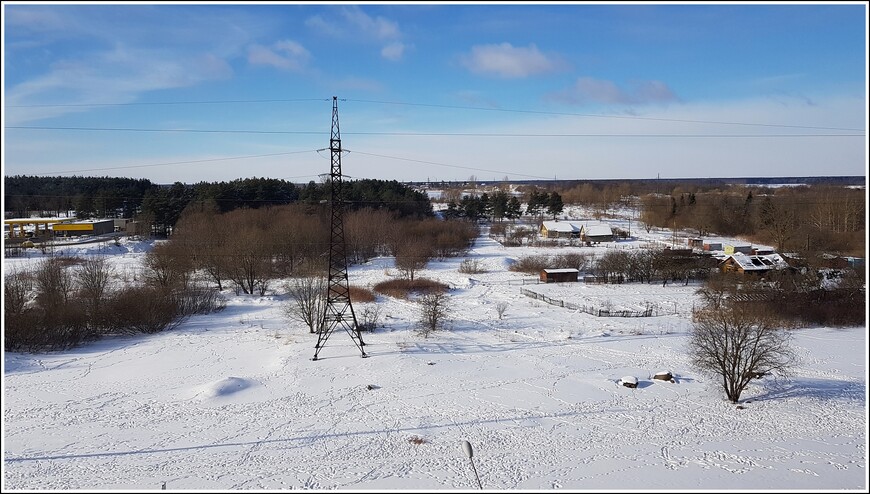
{"left": 312, "top": 96, "right": 368, "bottom": 360}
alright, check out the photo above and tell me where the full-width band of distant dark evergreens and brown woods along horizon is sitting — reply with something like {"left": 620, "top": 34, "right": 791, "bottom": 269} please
{"left": 4, "top": 176, "right": 867, "bottom": 256}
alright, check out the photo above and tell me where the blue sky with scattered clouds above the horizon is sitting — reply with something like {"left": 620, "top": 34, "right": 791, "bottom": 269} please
{"left": 3, "top": 2, "right": 868, "bottom": 183}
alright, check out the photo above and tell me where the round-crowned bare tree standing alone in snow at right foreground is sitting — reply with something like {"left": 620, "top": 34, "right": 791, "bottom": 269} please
{"left": 688, "top": 304, "right": 796, "bottom": 403}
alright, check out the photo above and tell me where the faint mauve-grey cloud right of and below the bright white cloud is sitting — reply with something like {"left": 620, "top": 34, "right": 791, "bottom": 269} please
{"left": 548, "top": 77, "right": 679, "bottom": 105}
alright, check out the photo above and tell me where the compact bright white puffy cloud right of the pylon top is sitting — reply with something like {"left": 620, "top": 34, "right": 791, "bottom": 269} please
{"left": 460, "top": 43, "right": 561, "bottom": 78}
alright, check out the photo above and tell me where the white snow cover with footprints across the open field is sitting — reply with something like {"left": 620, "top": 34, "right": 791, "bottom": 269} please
{"left": 3, "top": 225, "right": 868, "bottom": 492}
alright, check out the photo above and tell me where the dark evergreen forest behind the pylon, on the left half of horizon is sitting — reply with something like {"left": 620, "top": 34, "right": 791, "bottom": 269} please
{"left": 4, "top": 176, "right": 433, "bottom": 232}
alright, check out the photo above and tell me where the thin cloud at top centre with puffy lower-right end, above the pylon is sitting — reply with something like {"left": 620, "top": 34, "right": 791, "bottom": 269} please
{"left": 305, "top": 5, "right": 408, "bottom": 62}
